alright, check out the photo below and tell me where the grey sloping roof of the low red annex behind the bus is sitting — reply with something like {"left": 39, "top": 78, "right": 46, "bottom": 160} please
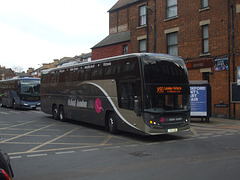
{"left": 92, "top": 30, "right": 130, "bottom": 49}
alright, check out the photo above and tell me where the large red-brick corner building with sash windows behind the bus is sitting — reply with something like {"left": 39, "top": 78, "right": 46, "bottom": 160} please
{"left": 92, "top": 0, "right": 240, "bottom": 119}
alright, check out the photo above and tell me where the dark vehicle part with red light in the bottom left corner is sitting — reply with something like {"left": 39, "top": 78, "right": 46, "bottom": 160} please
{"left": 0, "top": 150, "right": 14, "bottom": 180}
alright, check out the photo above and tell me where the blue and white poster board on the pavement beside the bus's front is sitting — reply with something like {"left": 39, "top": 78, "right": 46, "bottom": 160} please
{"left": 190, "top": 81, "right": 212, "bottom": 122}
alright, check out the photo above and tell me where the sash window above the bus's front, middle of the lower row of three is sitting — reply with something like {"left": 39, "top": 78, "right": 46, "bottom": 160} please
{"left": 167, "top": 32, "right": 178, "bottom": 56}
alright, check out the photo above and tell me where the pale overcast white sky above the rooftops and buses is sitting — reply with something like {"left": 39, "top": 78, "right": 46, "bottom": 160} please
{"left": 0, "top": 0, "right": 118, "bottom": 71}
